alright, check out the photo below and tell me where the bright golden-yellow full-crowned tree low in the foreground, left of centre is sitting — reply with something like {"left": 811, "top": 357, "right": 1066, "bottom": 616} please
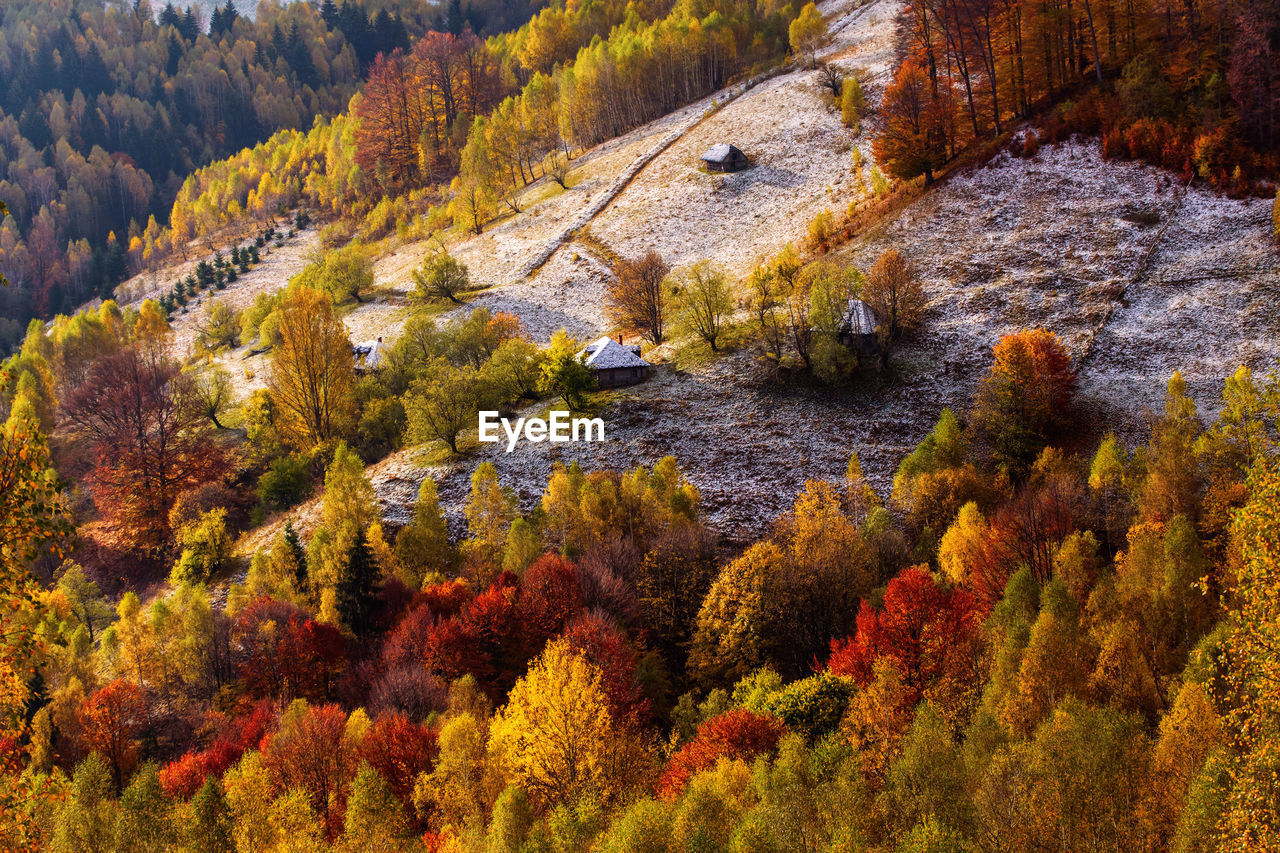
{"left": 489, "top": 639, "right": 648, "bottom": 806}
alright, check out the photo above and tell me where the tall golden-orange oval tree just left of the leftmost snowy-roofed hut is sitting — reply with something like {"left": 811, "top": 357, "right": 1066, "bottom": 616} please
{"left": 268, "top": 287, "right": 355, "bottom": 448}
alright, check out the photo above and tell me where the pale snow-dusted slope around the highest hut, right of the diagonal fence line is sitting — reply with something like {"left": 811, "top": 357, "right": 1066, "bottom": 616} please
{"left": 591, "top": 0, "right": 899, "bottom": 275}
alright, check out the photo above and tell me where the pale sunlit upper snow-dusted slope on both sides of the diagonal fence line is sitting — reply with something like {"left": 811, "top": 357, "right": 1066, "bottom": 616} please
{"left": 332, "top": 0, "right": 899, "bottom": 348}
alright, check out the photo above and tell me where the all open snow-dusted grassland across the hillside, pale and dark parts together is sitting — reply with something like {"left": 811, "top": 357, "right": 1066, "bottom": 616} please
{"left": 120, "top": 0, "right": 1280, "bottom": 549}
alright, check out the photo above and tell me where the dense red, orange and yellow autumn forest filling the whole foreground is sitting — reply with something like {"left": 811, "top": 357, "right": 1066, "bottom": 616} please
{"left": 0, "top": 317, "right": 1280, "bottom": 852}
